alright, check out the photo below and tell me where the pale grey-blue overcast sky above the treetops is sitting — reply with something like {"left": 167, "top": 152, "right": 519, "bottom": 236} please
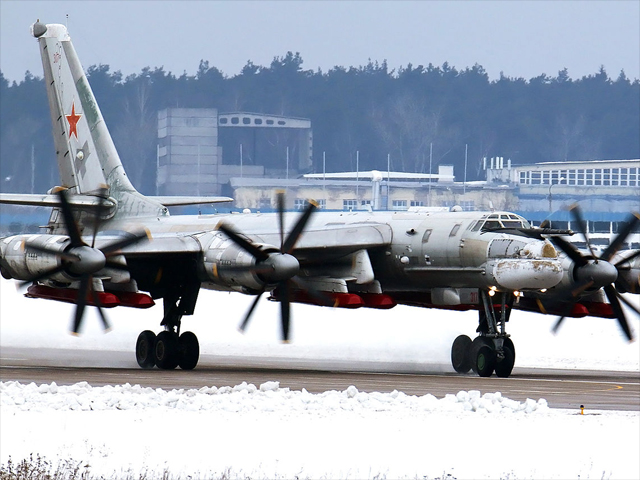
{"left": 0, "top": 0, "right": 640, "bottom": 80}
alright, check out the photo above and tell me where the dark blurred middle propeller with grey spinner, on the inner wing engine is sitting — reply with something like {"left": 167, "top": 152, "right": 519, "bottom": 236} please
{"left": 218, "top": 192, "right": 324, "bottom": 342}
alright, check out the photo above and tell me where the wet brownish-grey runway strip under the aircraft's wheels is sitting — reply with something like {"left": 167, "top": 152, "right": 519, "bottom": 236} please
{"left": 0, "top": 348, "right": 640, "bottom": 413}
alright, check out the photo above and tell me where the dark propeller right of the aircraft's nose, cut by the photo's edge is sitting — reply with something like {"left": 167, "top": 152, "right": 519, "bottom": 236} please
{"left": 550, "top": 204, "right": 640, "bottom": 341}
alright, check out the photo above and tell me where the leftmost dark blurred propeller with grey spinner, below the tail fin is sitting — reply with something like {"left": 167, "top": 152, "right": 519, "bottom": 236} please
{"left": 19, "top": 187, "right": 148, "bottom": 334}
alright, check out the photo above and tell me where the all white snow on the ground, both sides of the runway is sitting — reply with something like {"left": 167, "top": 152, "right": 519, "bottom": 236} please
{"left": 0, "top": 280, "right": 640, "bottom": 479}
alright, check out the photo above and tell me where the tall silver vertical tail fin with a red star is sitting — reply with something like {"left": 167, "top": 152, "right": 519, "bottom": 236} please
{"left": 31, "top": 21, "right": 166, "bottom": 215}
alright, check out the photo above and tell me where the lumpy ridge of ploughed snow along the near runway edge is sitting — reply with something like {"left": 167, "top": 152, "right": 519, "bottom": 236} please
{"left": 0, "top": 381, "right": 548, "bottom": 415}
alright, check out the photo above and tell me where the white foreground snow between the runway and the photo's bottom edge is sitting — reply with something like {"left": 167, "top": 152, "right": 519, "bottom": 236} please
{"left": 0, "top": 381, "right": 640, "bottom": 480}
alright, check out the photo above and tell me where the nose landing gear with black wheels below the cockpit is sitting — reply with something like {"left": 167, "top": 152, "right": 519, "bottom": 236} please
{"left": 451, "top": 290, "right": 516, "bottom": 378}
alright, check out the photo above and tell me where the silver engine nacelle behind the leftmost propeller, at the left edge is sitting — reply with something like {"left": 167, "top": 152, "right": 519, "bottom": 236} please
{"left": 0, "top": 234, "right": 72, "bottom": 282}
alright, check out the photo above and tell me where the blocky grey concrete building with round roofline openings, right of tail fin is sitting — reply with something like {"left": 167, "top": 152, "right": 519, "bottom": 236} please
{"left": 156, "top": 108, "right": 313, "bottom": 195}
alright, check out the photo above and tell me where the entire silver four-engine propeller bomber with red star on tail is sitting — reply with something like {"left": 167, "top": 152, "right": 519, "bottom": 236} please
{"left": 0, "top": 21, "right": 637, "bottom": 377}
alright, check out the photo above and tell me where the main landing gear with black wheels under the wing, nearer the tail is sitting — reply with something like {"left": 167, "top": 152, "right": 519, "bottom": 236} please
{"left": 136, "top": 284, "right": 200, "bottom": 370}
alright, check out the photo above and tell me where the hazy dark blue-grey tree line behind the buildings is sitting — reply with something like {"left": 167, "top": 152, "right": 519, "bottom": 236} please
{"left": 0, "top": 56, "right": 640, "bottom": 197}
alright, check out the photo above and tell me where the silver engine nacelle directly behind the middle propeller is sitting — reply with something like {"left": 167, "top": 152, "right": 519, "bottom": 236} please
{"left": 199, "top": 233, "right": 277, "bottom": 291}
